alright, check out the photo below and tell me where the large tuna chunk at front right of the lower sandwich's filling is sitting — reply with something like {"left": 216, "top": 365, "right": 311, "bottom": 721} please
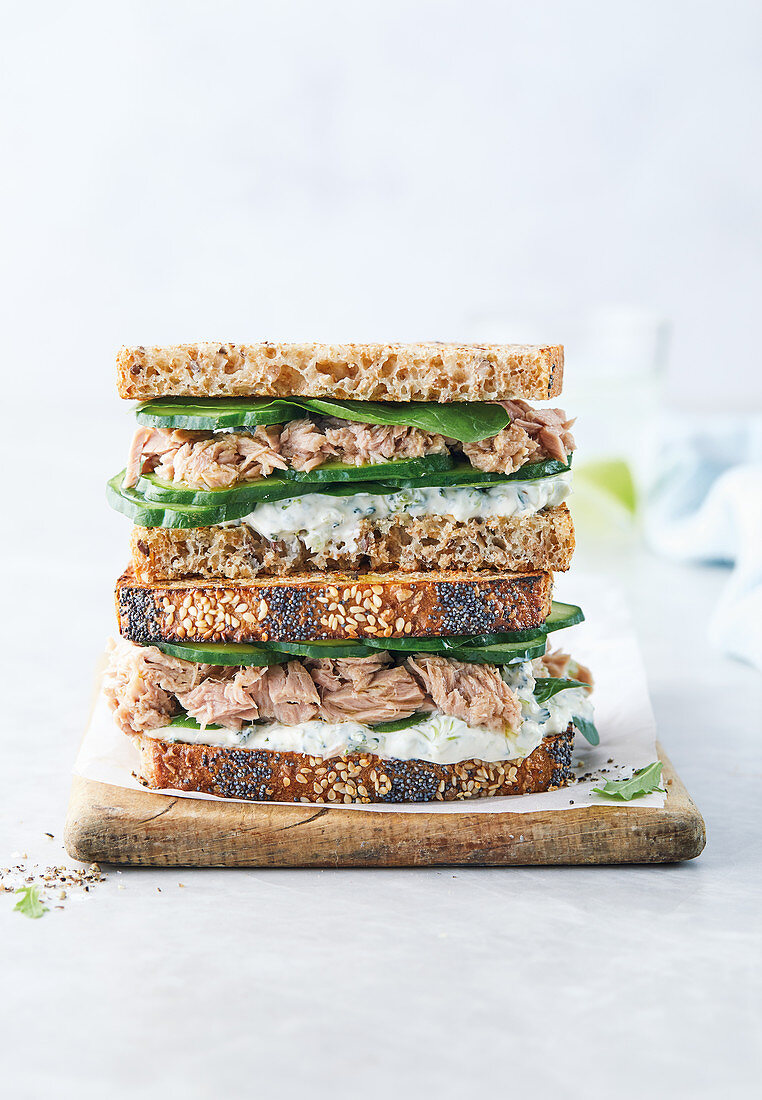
{"left": 406, "top": 656, "right": 521, "bottom": 733}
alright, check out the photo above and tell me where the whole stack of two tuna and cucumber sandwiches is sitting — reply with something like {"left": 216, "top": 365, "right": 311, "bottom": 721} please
{"left": 104, "top": 343, "right": 597, "bottom": 804}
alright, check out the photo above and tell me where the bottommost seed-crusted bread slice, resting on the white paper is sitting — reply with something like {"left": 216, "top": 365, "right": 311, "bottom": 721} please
{"left": 132, "top": 725, "right": 574, "bottom": 805}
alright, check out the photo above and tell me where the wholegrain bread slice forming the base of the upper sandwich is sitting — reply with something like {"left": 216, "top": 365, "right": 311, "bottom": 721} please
{"left": 131, "top": 504, "right": 574, "bottom": 583}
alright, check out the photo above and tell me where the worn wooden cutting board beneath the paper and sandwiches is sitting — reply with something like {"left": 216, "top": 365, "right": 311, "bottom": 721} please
{"left": 65, "top": 746, "right": 706, "bottom": 867}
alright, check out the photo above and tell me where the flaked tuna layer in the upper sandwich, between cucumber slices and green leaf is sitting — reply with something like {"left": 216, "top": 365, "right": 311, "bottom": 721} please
{"left": 124, "top": 400, "right": 574, "bottom": 490}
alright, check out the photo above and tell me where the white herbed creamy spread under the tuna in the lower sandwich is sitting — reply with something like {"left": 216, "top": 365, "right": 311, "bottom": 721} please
{"left": 146, "top": 661, "right": 593, "bottom": 763}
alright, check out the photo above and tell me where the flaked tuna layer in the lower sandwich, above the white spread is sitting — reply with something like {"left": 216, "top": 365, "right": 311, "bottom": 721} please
{"left": 104, "top": 639, "right": 521, "bottom": 734}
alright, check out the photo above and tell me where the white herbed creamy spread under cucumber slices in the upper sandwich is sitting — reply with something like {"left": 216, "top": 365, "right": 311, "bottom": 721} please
{"left": 236, "top": 473, "right": 572, "bottom": 552}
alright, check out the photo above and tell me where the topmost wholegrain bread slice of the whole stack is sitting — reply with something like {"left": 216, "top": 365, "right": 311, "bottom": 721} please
{"left": 117, "top": 342, "right": 564, "bottom": 402}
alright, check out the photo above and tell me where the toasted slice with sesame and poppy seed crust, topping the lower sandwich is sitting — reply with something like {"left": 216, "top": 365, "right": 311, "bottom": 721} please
{"left": 115, "top": 571, "right": 553, "bottom": 646}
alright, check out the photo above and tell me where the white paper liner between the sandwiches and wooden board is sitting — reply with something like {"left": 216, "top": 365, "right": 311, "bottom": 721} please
{"left": 74, "top": 575, "right": 664, "bottom": 814}
